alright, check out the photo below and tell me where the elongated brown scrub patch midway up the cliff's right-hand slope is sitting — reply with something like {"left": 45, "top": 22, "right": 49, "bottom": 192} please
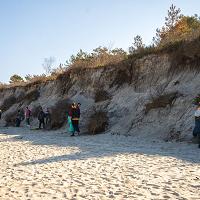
{"left": 145, "top": 92, "right": 181, "bottom": 114}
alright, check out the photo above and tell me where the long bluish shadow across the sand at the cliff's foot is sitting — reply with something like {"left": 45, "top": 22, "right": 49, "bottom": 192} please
{"left": 0, "top": 128, "right": 200, "bottom": 166}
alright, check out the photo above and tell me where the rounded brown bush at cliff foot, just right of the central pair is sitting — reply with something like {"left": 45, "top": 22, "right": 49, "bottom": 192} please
{"left": 88, "top": 111, "right": 108, "bottom": 134}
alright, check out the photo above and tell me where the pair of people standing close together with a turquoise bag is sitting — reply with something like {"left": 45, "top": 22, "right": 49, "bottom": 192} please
{"left": 68, "top": 103, "right": 81, "bottom": 136}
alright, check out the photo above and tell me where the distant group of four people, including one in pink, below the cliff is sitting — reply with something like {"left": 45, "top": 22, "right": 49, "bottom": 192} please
{"left": 15, "top": 107, "right": 51, "bottom": 129}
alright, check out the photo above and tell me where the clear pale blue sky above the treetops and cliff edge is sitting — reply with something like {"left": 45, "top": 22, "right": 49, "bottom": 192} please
{"left": 0, "top": 0, "right": 200, "bottom": 82}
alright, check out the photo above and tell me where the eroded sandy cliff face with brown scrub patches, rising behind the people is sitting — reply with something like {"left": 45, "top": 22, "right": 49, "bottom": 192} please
{"left": 0, "top": 38, "right": 200, "bottom": 140}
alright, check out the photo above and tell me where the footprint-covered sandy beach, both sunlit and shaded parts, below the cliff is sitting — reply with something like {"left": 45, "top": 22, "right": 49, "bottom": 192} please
{"left": 0, "top": 128, "right": 200, "bottom": 200}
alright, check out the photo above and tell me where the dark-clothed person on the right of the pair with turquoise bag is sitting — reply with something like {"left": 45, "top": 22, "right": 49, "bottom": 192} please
{"left": 71, "top": 103, "right": 80, "bottom": 136}
